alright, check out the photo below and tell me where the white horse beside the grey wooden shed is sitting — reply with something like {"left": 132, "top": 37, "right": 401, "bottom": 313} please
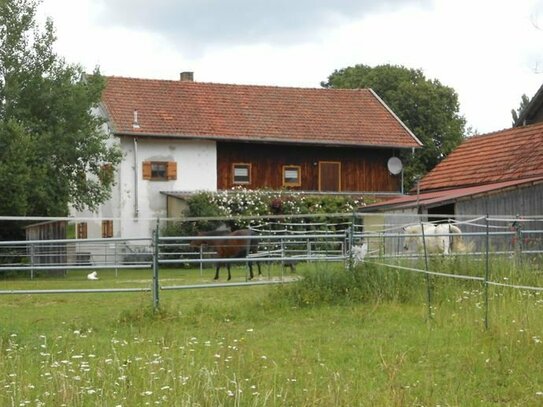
{"left": 403, "top": 223, "right": 468, "bottom": 254}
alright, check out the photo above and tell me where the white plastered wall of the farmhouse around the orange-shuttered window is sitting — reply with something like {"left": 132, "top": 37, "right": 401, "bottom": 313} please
{"left": 74, "top": 136, "right": 217, "bottom": 238}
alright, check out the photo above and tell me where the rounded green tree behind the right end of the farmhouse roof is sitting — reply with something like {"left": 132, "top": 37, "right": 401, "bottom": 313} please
{"left": 321, "top": 65, "right": 466, "bottom": 188}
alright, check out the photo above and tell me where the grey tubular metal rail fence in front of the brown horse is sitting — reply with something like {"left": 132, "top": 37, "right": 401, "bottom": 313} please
{"left": 0, "top": 228, "right": 352, "bottom": 307}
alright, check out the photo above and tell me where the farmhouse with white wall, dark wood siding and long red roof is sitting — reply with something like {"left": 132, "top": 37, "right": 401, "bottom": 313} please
{"left": 74, "top": 72, "right": 421, "bottom": 237}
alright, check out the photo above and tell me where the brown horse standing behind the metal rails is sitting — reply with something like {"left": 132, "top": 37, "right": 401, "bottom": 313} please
{"left": 190, "top": 229, "right": 262, "bottom": 280}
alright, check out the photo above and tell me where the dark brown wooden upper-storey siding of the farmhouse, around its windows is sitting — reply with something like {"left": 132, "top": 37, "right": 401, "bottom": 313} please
{"left": 217, "top": 143, "right": 400, "bottom": 192}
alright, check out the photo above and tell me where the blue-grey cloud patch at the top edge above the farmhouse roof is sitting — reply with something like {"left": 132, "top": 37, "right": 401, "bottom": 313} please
{"left": 91, "top": 0, "right": 429, "bottom": 52}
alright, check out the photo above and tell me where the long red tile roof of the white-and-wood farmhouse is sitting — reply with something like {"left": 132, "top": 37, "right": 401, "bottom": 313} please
{"left": 103, "top": 77, "right": 421, "bottom": 148}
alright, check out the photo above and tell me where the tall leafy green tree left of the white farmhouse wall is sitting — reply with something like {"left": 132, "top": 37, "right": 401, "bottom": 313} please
{"left": 0, "top": 0, "right": 121, "bottom": 236}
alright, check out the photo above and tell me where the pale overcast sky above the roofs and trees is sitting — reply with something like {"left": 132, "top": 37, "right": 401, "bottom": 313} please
{"left": 40, "top": 0, "right": 543, "bottom": 133}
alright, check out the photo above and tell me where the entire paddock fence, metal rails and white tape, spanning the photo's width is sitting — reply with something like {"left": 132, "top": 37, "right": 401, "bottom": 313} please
{"left": 0, "top": 213, "right": 543, "bottom": 326}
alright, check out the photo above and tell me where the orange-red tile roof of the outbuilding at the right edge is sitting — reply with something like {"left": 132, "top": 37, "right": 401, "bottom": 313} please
{"left": 420, "top": 123, "right": 543, "bottom": 191}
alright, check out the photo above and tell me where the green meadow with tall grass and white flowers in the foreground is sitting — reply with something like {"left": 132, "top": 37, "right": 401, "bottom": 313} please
{"left": 0, "top": 257, "right": 543, "bottom": 406}
